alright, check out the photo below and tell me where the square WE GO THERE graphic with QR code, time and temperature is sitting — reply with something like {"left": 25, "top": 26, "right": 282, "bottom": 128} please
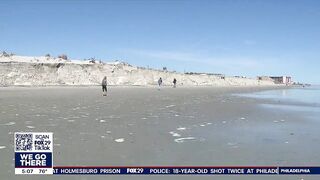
{"left": 14, "top": 132, "right": 53, "bottom": 174}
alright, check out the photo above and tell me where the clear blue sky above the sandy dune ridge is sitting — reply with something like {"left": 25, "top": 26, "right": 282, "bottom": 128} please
{"left": 0, "top": 0, "right": 320, "bottom": 84}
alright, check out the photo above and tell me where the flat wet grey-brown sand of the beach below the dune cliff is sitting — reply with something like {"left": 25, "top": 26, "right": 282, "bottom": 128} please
{"left": 0, "top": 87, "right": 320, "bottom": 180}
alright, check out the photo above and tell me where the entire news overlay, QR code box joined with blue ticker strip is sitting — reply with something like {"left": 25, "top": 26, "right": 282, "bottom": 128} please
{"left": 14, "top": 132, "right": 320, "bottom": 175}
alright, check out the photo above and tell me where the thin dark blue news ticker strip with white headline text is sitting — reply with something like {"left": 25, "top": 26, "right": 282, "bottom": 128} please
{"left": 53, "top": 166, "right": 320, "bottom": 175}
